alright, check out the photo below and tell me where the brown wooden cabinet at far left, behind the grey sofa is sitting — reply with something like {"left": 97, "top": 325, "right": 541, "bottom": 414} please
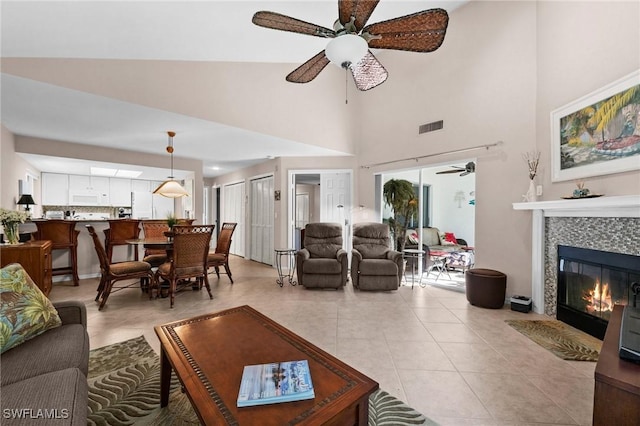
{"left": 0, "top": 240, "right": 52, "bottom": 296}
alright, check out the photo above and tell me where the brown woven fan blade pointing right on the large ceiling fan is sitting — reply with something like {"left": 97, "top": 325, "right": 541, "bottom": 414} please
{"left": 362, "top": 9, "right": 449, "bottom": 52}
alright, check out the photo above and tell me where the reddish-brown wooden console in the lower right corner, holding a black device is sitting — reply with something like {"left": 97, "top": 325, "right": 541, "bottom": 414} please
{"left": 593, "top": 305, "right": 640, "bottom": 426}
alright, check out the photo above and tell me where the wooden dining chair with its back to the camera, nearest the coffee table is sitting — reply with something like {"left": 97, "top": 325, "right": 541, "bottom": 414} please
{"left": 155, "top": 225, "right": 215, "bottom": 308}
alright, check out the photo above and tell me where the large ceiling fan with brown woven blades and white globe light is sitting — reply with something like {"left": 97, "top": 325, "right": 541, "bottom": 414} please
{"left": 252, "top": 0, "right": 449, "bottom": 91}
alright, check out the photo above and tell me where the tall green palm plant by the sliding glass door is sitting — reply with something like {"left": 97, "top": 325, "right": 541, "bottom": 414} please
{"left": 382, "top": 179, "right": 418, "bottom": 251}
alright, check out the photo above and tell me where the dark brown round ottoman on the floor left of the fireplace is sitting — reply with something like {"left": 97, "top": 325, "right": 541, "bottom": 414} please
{"left": 464, "top": 268, "right": 507, "bottom": 309}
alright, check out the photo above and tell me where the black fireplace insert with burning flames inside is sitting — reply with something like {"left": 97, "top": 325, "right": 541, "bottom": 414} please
{"left": 557, "top": 245, "right": 640, "bottom": 339}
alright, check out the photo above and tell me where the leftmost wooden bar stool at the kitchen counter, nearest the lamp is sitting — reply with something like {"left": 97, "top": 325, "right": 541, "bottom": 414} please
{"left": 32, "top": 219, "right": 80, "bottom": 286}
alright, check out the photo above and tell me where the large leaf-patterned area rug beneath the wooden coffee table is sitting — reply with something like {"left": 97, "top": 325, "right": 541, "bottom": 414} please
{"left": 87, "top": 336, "right": 437, "bottom": 426}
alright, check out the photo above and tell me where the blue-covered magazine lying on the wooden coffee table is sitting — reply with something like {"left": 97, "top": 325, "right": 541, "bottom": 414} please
{"left": 238, "top": 360, "right": 315, "bottom": 407}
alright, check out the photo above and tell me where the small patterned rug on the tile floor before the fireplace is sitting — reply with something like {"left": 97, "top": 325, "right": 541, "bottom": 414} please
{"left": 505, "top": 320, "right": 602, "bottom": 361}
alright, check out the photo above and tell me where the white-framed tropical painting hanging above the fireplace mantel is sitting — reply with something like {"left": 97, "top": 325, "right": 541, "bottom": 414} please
{"left": 551, "top": 70, "right": 640, "bottom": 182}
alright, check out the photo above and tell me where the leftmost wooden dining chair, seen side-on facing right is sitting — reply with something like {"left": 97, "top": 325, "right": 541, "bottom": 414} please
{"left": 86, "top": 225, "right": 155, "bottom": 310}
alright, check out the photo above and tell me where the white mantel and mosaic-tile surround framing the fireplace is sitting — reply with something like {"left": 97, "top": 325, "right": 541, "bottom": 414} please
{"left": 513, "top": 195, "right": 640, "bottom": 317}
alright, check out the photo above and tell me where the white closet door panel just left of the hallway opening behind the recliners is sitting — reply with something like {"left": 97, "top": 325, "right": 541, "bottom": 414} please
{"left": 250, "top": 176, "right": 274, "bottom": 265}
